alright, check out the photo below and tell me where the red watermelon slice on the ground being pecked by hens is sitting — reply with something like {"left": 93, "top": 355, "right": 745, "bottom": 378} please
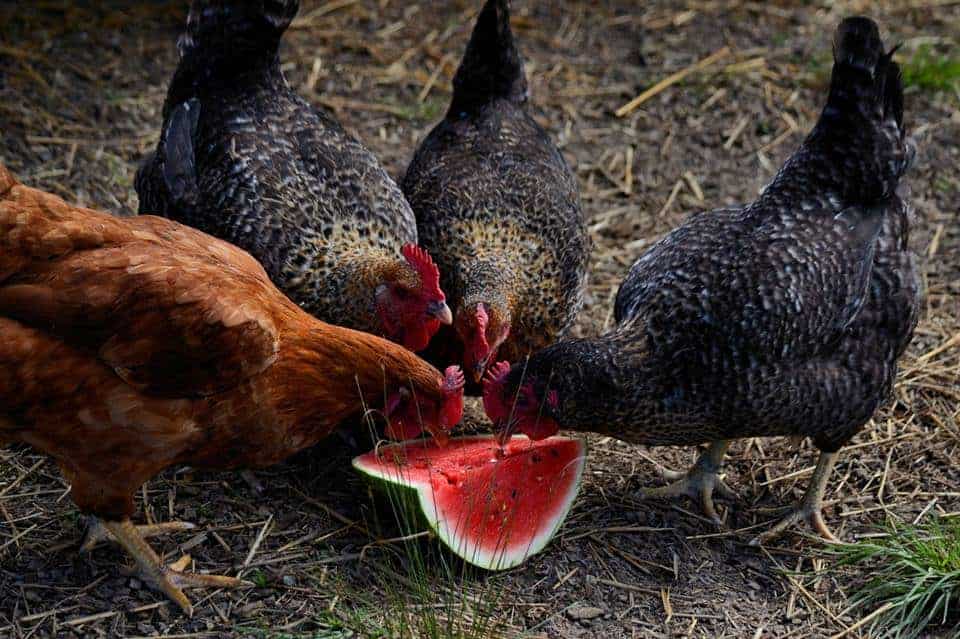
{"left": 353, "top": 435, "right": 586, "bottom": 570}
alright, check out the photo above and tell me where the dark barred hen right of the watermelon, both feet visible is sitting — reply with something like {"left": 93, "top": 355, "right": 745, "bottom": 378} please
{"left": 484, "top": 18, "right": 921, "bottom": 542}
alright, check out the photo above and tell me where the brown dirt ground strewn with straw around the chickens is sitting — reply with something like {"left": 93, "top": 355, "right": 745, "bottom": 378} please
{"left": 0, "top": 0, "right": 960, "bottom": 639}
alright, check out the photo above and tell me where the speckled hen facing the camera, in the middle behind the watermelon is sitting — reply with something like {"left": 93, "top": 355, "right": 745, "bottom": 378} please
{"left": 401, "top": 0, "right": 590, "bottom": 382}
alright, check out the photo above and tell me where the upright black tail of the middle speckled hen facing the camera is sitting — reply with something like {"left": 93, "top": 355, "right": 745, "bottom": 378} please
{"left": 450, "top": 0, "right": 527, "bottom": 113}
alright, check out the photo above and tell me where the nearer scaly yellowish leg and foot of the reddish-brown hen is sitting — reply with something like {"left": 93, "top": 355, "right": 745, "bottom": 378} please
{"left": 101, "top": 519, "right": 252, "bottom": 616}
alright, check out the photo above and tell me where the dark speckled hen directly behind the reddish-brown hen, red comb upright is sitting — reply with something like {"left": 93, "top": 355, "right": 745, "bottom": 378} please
{"left": 136, "top": 0, "right": 452, "bottom": 351}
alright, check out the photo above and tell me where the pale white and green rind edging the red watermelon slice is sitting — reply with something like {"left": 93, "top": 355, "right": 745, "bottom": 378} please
{"left": 353, "top": 435, "right": 586, "bottom": 571}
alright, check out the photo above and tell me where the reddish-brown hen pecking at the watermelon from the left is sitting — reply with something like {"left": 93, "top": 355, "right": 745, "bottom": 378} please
{"left": 0, "top": 166, "right": 464, "bottom": 614}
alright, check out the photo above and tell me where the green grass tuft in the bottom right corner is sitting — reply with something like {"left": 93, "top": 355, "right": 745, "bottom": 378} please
{"left": 830, "top": 519, "right": 960, "bottom": 639}
